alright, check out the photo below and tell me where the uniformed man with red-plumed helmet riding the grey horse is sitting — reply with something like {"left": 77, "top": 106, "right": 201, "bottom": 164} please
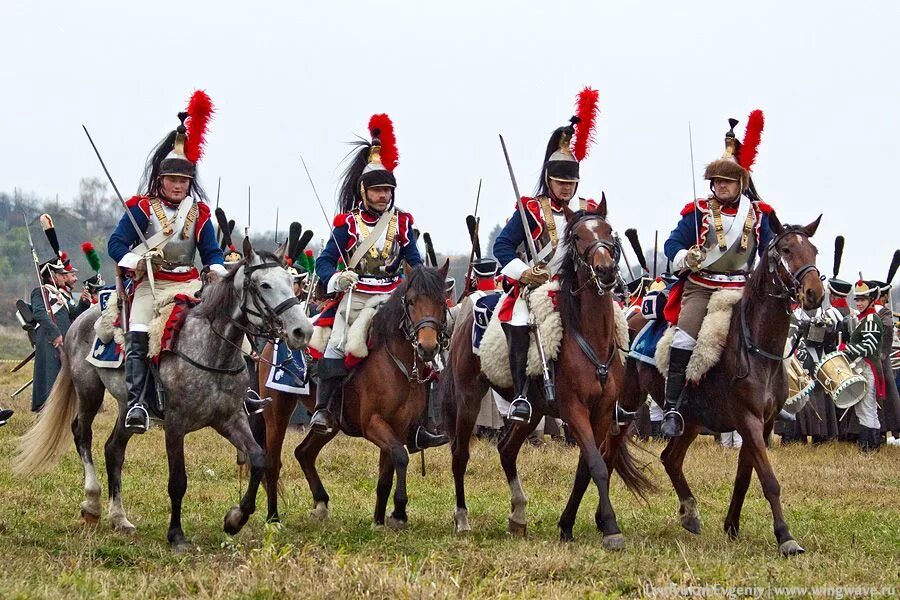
{"left": 107, "top": 91, "right": 226, "bottom": 433}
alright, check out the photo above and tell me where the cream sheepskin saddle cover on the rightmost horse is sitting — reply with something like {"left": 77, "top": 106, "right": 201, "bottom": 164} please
{"left": 647, "top": 289, "right": 743, "bottom": 383}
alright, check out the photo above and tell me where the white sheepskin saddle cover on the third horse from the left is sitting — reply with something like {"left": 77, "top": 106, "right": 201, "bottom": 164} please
{"left": 472, "top": 281, "right": 628, "bottom": 389}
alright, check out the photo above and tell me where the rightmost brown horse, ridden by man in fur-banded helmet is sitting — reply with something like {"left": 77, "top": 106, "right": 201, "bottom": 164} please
{"left": 569, "top": 213, "right": 825, "bottom": 556}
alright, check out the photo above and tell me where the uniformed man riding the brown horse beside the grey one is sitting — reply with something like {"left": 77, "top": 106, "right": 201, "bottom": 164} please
{"left": 310, "top": 114, "right": 446, "bottom": 448}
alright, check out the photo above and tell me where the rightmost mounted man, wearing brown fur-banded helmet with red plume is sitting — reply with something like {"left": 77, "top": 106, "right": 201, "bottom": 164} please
{"left": 661, "top": 116, "right": 772, "bottom": 437}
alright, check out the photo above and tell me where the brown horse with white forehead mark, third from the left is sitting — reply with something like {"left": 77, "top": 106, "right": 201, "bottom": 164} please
{"left": 440, "top": 200, "right": 651, "bottom": 549}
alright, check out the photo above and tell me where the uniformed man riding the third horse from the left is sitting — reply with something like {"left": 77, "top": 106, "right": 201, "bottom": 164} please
{"left": 493, "top": 88, "right": 598, "bottom": 422}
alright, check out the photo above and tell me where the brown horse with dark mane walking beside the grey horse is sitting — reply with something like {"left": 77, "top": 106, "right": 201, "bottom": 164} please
{"left": 296, "top": 260, "right": 450, "bottom": 529}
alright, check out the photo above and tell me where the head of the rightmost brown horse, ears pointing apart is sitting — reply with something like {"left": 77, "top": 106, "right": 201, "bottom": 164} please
{"left": 768, "top": 212, "right": 825, "bottom": 310}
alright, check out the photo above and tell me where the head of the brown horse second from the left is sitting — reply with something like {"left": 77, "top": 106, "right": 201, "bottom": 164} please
{"left": 402, "top": 260, "right": 450, "bottom": 361}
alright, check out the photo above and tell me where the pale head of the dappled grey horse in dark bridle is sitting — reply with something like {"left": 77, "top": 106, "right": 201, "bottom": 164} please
{"left": 232, "top": 238, "right": 312, "bottom": 350}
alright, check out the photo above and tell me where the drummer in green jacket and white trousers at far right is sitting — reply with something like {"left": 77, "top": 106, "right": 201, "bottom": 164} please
{"left": 843, "top": 280, "right": 885, "bottom": 452}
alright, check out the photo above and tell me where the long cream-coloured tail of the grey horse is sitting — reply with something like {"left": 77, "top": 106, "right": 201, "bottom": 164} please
{"left": 12, "top": 351, "right": 78, "bottom": 475}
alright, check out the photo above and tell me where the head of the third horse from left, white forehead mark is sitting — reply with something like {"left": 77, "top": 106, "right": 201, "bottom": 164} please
{"left": 563, "top": 198, "right": 621, "bottom": 294}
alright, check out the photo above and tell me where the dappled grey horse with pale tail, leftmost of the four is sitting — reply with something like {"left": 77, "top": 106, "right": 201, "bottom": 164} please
{"left": 13, "top": 240, "right": 312, "bottom": 551}
